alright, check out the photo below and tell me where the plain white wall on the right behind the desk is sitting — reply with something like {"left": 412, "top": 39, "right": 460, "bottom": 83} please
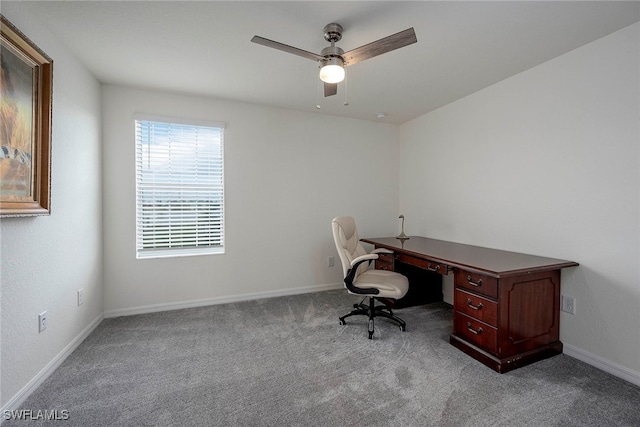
{"left": 400, "top": 24, "right": 640, "bottom": 383}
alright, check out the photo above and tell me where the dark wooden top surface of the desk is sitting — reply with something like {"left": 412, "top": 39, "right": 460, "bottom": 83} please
{"left": 361, "top": 236, "right": 579, "bottom": 277}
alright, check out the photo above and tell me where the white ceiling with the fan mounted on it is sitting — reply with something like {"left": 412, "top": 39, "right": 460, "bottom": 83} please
{"left": 26, "top": 1, "right": 640, "bottom": 123}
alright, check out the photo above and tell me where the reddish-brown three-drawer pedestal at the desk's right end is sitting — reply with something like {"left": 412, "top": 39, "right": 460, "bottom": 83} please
{"left": 449, "top": 270, "right": 562, "bottom": 373}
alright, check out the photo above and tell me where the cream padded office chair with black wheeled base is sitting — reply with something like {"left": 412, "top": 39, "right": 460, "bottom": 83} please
{"left": 331, "top": 216, "right": 409, "bottom": 339}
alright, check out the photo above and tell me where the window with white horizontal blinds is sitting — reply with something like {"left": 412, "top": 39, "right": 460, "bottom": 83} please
{"left": 135, "top": 117, "right": 224, "bottom": 258}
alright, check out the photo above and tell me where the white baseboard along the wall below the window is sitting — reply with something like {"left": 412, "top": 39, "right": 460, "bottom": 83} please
{"left": 104, "top": 283, "right": 344, "bottom": 318}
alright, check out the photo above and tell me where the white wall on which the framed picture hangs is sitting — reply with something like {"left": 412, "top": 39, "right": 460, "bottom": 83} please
{"left": 0, "top": 2, "right": 103, "bottom": 408}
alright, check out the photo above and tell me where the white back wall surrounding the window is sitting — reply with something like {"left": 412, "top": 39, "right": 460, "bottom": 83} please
{"left": 103, "top": 86, "right": 398, "bottom": 316}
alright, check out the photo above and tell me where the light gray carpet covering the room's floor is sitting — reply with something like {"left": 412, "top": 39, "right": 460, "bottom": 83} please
{"left": 3, "top": 290, "right": 640, "bottom": 427}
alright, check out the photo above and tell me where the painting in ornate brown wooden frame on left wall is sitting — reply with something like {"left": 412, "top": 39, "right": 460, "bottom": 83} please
{"left": 0, "top": 15, "right": 53, "bottom": 216}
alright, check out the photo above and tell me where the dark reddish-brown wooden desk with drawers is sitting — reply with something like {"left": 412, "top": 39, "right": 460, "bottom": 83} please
{"left": 361, "top": 236, "right": 578, "bottom": 373}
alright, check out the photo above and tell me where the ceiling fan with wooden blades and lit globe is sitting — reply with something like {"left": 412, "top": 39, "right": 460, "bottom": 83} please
{"left": 251, "top": 23, "right": 418, "bottom": 96}
